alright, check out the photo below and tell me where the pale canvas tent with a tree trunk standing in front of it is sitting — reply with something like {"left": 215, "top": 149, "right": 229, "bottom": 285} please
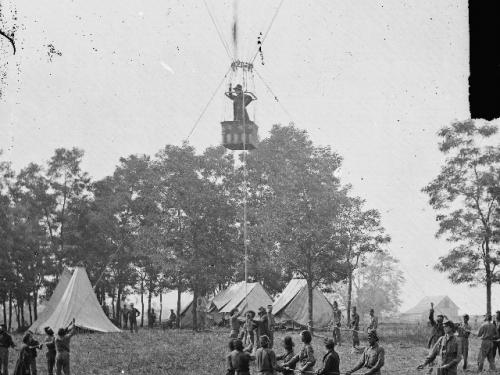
{"left": 273, "top": 279, "right": 333, "bottom": 328}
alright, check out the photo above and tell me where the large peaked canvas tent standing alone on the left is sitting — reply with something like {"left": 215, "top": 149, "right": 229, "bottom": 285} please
{"left": 30, "top": 267, "right": 120, "bottom": 333}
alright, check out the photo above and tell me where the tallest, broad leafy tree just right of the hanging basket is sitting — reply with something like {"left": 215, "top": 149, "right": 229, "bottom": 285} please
{"left": 247, "top": 125, "right": 346, "bottom": 330}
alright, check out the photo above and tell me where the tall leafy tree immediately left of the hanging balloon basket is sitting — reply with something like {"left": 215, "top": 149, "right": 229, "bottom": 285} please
{"left": 155, "top": 144, "right": 237, "bottom": 329}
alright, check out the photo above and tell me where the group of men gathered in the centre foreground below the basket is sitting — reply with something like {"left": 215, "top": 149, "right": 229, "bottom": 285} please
{"left": 226, "top": 303, "right": 385, "bottom": 375}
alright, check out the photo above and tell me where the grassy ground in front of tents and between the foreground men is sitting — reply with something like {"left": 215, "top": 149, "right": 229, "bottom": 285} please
{"left": 4, "top": 329, "right": 488, "bottom": 375}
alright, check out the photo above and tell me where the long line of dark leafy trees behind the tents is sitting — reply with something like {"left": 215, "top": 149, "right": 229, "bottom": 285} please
{"left": 0, "top": 124, "right": 399, "bottom": 328}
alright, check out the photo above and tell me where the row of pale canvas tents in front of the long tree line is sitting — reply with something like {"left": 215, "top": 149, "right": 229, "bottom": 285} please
{"left": 30, "top": 267, "right": 333, "bottom": 333}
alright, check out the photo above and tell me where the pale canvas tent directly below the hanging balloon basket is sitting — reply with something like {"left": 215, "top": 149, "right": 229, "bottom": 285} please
{"left": 210, "top": 281, "right": 273, "bottom": 320}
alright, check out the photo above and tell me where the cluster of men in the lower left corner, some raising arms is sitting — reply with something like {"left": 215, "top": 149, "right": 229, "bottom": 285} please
{"left": 0, "top": 319, "right": 76, "bottom": 375}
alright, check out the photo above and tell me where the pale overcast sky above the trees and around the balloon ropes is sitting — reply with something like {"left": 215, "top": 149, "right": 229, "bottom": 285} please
{"left": 0, "top": 0, "right": 500, "bottom": 313}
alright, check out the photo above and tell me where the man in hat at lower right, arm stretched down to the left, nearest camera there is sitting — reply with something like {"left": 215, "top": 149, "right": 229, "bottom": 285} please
{"left": 417, "top": 320, "right": 462, "bottom": 375}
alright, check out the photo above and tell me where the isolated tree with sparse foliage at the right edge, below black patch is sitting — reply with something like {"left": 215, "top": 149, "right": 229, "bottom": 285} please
{"left": 423, "top": 120, "right": 500, "bottom": 314}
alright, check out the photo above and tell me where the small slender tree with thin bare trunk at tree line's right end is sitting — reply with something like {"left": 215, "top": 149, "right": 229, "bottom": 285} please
{"left": 334, "top": 197, "right": 390, "bottom": 324}
